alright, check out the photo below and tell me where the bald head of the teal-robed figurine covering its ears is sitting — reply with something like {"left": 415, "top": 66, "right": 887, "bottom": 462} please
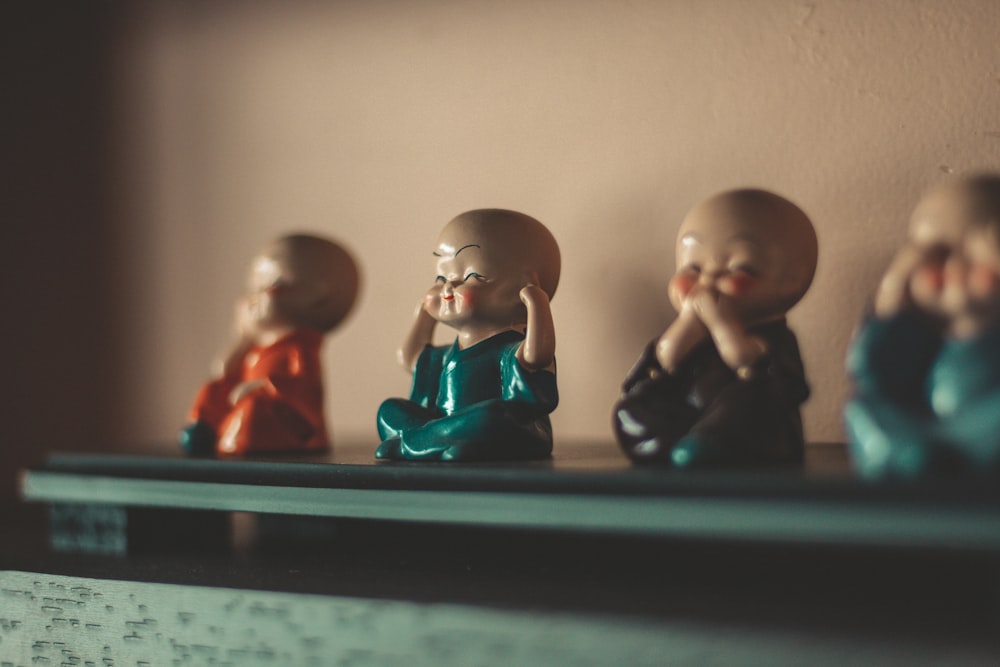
{"left": 425, "top": 209, "right": 560, "bottom": 330}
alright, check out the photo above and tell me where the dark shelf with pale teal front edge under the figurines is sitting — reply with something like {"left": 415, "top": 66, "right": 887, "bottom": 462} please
{"left": 17, "top": 443, "right": 1000, "bottom": 552}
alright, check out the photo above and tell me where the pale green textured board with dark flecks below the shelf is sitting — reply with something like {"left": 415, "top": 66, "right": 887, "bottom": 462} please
{"left": 0, "top": 571, "right": 997, "bottom": 667}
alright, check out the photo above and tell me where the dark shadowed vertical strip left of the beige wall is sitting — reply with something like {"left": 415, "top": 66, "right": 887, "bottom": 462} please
{"left": 0, "top": 2, "right": 126, "bottom": 498}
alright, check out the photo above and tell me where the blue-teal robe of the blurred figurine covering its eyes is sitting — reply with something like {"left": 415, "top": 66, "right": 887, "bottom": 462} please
{"left": 844, "top": 313, "right": 1000, "bottom": 478}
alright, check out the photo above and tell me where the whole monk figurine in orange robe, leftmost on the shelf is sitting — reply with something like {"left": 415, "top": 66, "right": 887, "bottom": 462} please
{"left": 180, "top": 234, "right": 359, "bottom": 456}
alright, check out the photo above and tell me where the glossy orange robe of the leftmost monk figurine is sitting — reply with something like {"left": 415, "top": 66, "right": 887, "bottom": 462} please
{"left": 190, "top": 329, "right": 329, "bottom": 454}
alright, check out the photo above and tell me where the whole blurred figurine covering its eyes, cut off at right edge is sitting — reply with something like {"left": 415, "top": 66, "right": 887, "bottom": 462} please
{"left": 845, "top": 174, "right": 1000, "bottom": 478}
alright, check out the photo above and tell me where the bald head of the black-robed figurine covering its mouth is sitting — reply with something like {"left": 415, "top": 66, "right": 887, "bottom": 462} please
{"left": 670, "top": 189, "right": 818, "bottom": 326}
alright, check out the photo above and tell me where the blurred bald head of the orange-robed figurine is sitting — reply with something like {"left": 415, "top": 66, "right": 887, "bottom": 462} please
{"left": 247, "top": 234, "right": 359, "bottom": 340}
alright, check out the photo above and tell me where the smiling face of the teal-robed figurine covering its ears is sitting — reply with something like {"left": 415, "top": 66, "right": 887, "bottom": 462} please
{"left": 425, "top": 217, "right": 530, "bottom": 330}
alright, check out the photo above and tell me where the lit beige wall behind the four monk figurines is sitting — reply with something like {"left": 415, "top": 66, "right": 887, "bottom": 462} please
{"left": 114, "top": 0, "right": 1000, "bottom": 454}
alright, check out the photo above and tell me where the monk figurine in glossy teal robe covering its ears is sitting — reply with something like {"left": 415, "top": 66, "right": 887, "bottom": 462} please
{"left": 375, "top": 209, "right": 560, "bottom": 461}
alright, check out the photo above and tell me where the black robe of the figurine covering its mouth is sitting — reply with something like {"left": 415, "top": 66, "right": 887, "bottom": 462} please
{"left": 614, "top": 320, "right": 809, "bottom": 465}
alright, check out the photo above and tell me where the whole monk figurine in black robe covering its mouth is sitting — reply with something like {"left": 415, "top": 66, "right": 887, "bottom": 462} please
{"left": 613, "top": 189, "right": 818, "bottom": 468}
